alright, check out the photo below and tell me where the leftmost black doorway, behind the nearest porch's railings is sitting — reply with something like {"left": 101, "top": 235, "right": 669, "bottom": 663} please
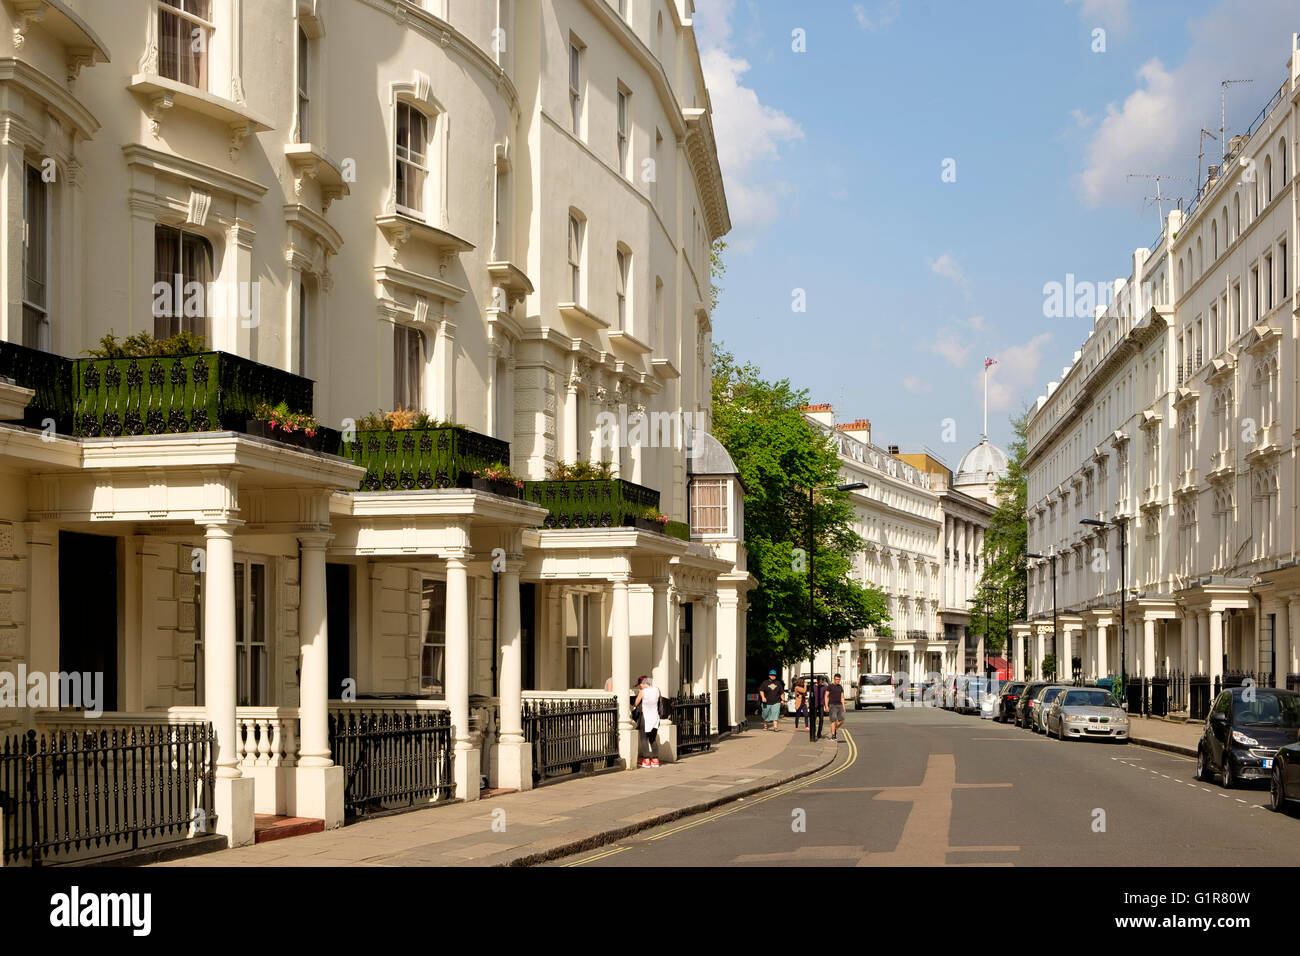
{"left": 59, "top": 531, "right": 117, "bottom": 710}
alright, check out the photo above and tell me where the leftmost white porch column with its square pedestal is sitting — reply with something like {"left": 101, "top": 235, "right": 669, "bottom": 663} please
{"left": 203, "top": 519, "right": 254, "bottom": 847}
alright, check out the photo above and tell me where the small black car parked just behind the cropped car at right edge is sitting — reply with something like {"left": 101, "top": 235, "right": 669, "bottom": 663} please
{"left": 1196, "top": 687, "right": 1300, "bottom": 787}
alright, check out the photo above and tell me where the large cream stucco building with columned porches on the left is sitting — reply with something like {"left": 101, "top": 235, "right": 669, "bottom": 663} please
{"left": 0, "top": 0, "right": 753, "bottom": 858}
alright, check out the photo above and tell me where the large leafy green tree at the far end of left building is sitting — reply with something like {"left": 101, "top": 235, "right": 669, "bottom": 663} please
{"left": 712, "top": 346, "right": 889, "bottom": 672}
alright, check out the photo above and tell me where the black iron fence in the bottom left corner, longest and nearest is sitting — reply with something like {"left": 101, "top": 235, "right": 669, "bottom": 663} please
{"left": 0, "top": 723, "right": 216, "bottom": 866}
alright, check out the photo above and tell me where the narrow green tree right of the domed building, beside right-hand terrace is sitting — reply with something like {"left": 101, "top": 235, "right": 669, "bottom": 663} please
{"left": 972, "top": 408, "right": 1030, "bottom": 660}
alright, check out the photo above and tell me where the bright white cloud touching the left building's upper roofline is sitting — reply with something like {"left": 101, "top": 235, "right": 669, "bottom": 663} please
{"left": 696, "top": 0, "right": 803, "bottom": 230}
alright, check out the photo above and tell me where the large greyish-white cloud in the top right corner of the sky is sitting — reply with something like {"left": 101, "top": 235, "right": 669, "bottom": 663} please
{"left": 1078, "top": 0, "right": 1296, "bottom": 211}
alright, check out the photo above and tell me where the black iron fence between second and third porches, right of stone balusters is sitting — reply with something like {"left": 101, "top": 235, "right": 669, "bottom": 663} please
{"left": 329, "top": 709, "right": 455, "bottom": 817}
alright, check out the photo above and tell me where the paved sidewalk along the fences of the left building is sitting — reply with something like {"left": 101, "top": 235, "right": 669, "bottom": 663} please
{"left": 156, "top": 721, "right": 846, "bottom": 866}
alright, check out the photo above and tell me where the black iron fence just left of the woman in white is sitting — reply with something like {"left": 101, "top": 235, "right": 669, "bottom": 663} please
{"left": 524, "top": 697, "right": 619, "bottom": 783}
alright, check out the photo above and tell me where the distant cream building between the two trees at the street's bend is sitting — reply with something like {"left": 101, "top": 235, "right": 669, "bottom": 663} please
{"left": 792, "top": 405, "right": 993, "bottom": 685}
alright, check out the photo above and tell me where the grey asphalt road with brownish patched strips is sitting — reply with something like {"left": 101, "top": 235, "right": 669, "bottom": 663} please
{"left": 554, "top": 708, "right": 1300, "bottom": 866}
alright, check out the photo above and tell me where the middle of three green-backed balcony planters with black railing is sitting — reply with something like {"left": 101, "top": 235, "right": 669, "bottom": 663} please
{"left": 343, "top": 428, "right": 510, "bottom": 492}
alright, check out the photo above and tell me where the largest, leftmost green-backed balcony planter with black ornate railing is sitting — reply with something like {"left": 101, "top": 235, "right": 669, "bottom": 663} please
{"left": 72, "top": 352, "right": 312, "bottom": 438}
